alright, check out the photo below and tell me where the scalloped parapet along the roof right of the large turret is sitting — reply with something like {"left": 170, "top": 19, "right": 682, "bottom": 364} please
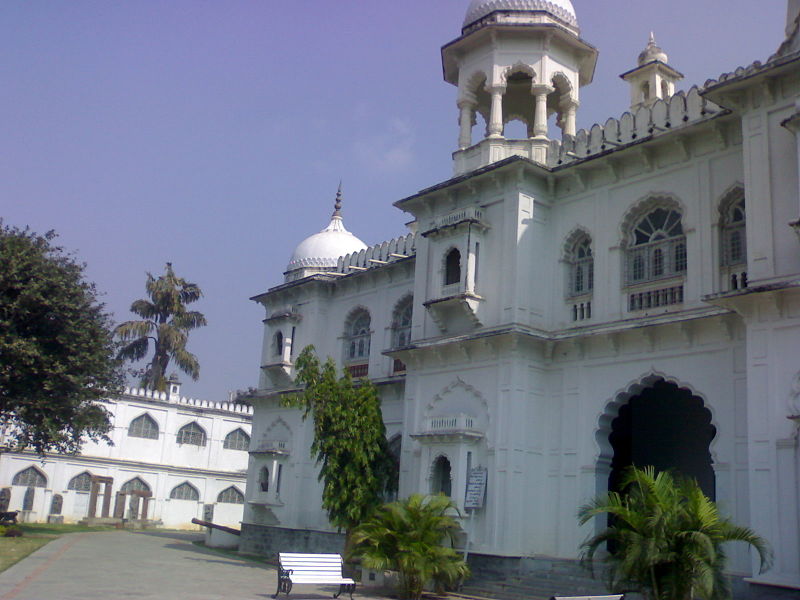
{"left": 547, "top": 83, "right": 725, "bottom": 167}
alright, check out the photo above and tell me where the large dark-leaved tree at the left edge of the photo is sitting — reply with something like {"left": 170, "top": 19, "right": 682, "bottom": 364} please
{"left": 0, "top": 221, "right": 122, "bottom": 454}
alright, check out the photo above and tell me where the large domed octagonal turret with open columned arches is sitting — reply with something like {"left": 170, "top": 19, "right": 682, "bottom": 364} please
{"left": 442, "top": 0, "right": 597, "bottom": 174}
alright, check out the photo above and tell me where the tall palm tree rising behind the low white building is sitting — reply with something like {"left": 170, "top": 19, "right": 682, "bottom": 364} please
{"left": 114, "top": 263, "right": 206, "bottom": 392}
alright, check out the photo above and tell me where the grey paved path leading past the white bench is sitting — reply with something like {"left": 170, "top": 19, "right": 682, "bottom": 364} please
{"left": 0, "top": 531, "right": 380, "bottom": 600}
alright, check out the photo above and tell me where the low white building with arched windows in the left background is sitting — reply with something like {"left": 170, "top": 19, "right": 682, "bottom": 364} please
{"left": 0, "top": 382, "right": 253, "bottom": 528}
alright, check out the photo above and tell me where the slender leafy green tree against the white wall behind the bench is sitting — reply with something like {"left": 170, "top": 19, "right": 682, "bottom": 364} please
{"left": 287, "top": 346, "right": 395, "bottom": 539}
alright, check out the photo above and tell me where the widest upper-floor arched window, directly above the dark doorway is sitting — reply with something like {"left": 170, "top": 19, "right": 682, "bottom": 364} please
{"left": 626, "top": 208, "right": 687, "bottom": 285}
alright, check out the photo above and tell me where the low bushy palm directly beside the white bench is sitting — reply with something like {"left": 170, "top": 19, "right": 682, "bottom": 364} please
{"left": 352, "top": 494, "right": 469, "bottom": 600}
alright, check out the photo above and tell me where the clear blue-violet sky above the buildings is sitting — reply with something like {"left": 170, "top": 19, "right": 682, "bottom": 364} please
{"left": 0, "top": 0, "right": 786, "bottom": 400}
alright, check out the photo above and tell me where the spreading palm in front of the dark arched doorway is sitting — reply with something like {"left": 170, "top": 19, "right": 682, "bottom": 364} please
{"left": 579, "top": 467, "right": 772, "bottom": 600}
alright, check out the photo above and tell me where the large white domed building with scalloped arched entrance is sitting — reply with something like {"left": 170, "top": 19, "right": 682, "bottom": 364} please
{"left": 243, "top": 0, "right": 800, "bottom": 597}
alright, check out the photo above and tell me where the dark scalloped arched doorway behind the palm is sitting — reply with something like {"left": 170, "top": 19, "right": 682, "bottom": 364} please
{"left": 607, "top": 378, "right": 716, "bottom": 500}
